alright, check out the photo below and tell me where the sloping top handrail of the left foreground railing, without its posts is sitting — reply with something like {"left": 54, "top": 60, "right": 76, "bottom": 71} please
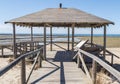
{"left": 0, "top": 47, "right": 43, "bottom": 76}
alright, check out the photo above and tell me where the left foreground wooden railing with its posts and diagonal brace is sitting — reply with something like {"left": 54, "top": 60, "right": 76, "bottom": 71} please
{"left": 0, "top": 47, "right": 43, "bottom": 84}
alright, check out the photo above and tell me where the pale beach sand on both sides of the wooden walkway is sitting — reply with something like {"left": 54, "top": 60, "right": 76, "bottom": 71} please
{"left": 0, "top": 47, "right": 120, "bottom": 84}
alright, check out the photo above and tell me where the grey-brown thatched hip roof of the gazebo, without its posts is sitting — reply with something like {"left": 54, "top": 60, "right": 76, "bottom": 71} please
{"left": 6, "top": 8, "right": 114, "bottom": 27}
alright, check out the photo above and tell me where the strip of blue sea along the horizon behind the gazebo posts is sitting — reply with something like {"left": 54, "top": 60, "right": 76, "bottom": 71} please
{"left": 0, "top": 33, "right": 120, "bottom": 44}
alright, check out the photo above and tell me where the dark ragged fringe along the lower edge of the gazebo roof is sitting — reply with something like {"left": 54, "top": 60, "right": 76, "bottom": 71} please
{"left": 5, "top": 22, "right": 114, "bottom": 28}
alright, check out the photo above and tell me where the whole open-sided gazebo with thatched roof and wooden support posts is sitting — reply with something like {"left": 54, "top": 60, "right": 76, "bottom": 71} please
{"left": 5, "top": 5, "right": 114, "bottom": 57}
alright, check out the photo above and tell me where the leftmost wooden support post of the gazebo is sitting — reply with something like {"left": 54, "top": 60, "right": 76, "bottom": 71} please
{"left": 13, "top": 23, "right": 17, "bottom": 58}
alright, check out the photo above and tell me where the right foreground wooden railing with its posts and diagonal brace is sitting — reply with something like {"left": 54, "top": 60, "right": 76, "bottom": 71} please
{"left": 77, "top": 49, "right": 120, "bottom": 84}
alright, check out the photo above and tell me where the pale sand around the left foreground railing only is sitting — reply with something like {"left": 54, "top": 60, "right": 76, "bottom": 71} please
{"left": 0, "top": 58, "right": 31, "bottom": 84}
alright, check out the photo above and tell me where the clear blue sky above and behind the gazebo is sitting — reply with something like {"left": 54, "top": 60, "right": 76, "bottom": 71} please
{"left": 0, "top": 0, "right": 120, "bottom": 34}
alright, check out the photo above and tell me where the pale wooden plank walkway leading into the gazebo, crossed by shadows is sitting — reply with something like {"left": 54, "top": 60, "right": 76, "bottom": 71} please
{"left": 29, "top": 51, "right": 92, "bottom": 84}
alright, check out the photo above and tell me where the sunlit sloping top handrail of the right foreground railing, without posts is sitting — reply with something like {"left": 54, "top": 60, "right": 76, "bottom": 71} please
{"left": 78, "top": 49, "right": 120, "bottom": 82}
